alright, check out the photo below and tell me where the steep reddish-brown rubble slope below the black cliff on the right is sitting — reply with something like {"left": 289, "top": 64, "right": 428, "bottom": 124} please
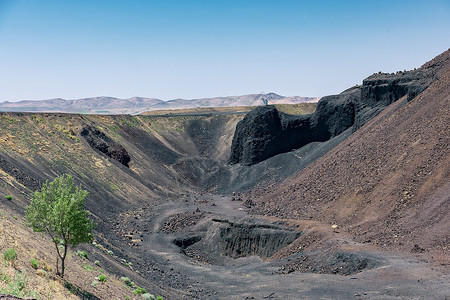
{"left": 247, "top": 51, "right": 450, "bottom": 264}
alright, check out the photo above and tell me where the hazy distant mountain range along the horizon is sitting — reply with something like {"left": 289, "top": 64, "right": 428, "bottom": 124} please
{"left": 0, "top": 93, "right": 320, "bottom": 114}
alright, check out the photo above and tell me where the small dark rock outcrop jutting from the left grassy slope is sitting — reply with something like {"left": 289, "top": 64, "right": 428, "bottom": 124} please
{"left": 80, "top": 125, "right": 130, "bottom": 168}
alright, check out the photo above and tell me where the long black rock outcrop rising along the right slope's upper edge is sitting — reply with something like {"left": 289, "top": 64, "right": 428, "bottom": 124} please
{"left": 229, "top": 57, "right": 446, "bottom": 165}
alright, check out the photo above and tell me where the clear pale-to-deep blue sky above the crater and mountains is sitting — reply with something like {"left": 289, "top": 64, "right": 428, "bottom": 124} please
{"left": 0, "top": 0, "right": 450, "bottom": 102}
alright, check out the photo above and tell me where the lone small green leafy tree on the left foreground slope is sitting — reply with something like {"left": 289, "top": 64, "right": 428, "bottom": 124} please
{"left": 26, "top": 174, "right": 96, "bottom": 277}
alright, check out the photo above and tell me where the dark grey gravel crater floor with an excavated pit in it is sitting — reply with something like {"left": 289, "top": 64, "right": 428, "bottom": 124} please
{"left": 110, "top": 195, "right": 449, "bottom": 299}
